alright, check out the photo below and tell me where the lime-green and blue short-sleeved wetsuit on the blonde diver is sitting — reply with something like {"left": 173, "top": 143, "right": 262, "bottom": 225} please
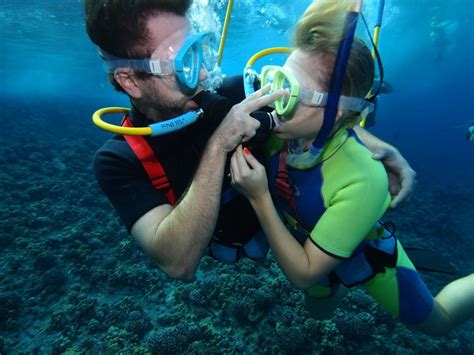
{"left": 268, "top": 128, "right": 433, "bottom": 324}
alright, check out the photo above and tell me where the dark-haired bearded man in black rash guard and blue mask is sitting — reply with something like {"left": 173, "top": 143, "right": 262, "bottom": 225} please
{"left": 85, "top": 0, "right": 415, "bottom": 280}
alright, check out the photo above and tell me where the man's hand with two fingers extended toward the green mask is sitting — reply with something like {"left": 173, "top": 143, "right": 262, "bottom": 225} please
{"left": 210, "top": 85, "right": 284, "bottom": 153}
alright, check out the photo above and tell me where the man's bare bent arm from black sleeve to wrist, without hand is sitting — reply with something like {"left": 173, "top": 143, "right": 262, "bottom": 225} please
{"left": 131, "top": 139, "right": 227, "bottom": 279}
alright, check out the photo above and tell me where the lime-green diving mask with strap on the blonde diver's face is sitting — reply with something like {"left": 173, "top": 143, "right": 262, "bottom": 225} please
{"left": 260, "top": 65, "right": 374, "bottom": 121}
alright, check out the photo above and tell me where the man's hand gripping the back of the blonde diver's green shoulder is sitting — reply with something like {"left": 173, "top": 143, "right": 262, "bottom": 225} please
{"left": 372, "top": 144, "right": 416, "bottom": 208}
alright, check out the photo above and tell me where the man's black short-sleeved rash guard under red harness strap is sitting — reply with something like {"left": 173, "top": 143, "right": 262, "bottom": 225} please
{"left": 94, "top": 78, "right": 259, "bottom": 244}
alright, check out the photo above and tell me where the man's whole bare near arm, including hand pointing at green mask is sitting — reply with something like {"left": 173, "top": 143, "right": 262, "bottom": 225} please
{"left": 131, "top": 88, "right": 283, "bottom": 280}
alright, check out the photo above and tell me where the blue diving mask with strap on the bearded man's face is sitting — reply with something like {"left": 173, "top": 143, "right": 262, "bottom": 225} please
{"left": 100, "top": 32, "right": 218, "bottom": 92}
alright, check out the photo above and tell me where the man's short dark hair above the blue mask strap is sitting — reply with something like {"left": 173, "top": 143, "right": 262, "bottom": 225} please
{"left": 84, "top": 0, "right": 192, "bottom": 91}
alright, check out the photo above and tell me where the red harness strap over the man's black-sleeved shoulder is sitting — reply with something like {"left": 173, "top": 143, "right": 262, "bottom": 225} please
{"left": 122, "top": 116, "right": 176, "bottom": 205}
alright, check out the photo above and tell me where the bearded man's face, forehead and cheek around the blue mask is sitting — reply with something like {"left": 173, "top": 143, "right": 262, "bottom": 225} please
{"left": 137, "top": 14, "right": 206, "bottom": 120}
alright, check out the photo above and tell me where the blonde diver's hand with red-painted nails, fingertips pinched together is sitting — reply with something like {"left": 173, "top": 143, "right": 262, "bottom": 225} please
{"left": 230, "top": 145, "right": 270, "bottom": 203}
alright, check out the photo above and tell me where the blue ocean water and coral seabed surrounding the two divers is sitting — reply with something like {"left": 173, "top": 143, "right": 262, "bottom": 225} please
{"left": 0, "top": 0, "right": 474, "bottom": 354}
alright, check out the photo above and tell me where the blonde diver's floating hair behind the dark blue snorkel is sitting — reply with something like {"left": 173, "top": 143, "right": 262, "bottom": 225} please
{"left": 293, "top": 0, "right": 375, "bottom": 97}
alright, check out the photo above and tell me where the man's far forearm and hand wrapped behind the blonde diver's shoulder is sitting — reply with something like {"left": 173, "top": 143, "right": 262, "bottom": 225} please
{"left": 354, "top": 126, "right": 416, "bottom": 208}
